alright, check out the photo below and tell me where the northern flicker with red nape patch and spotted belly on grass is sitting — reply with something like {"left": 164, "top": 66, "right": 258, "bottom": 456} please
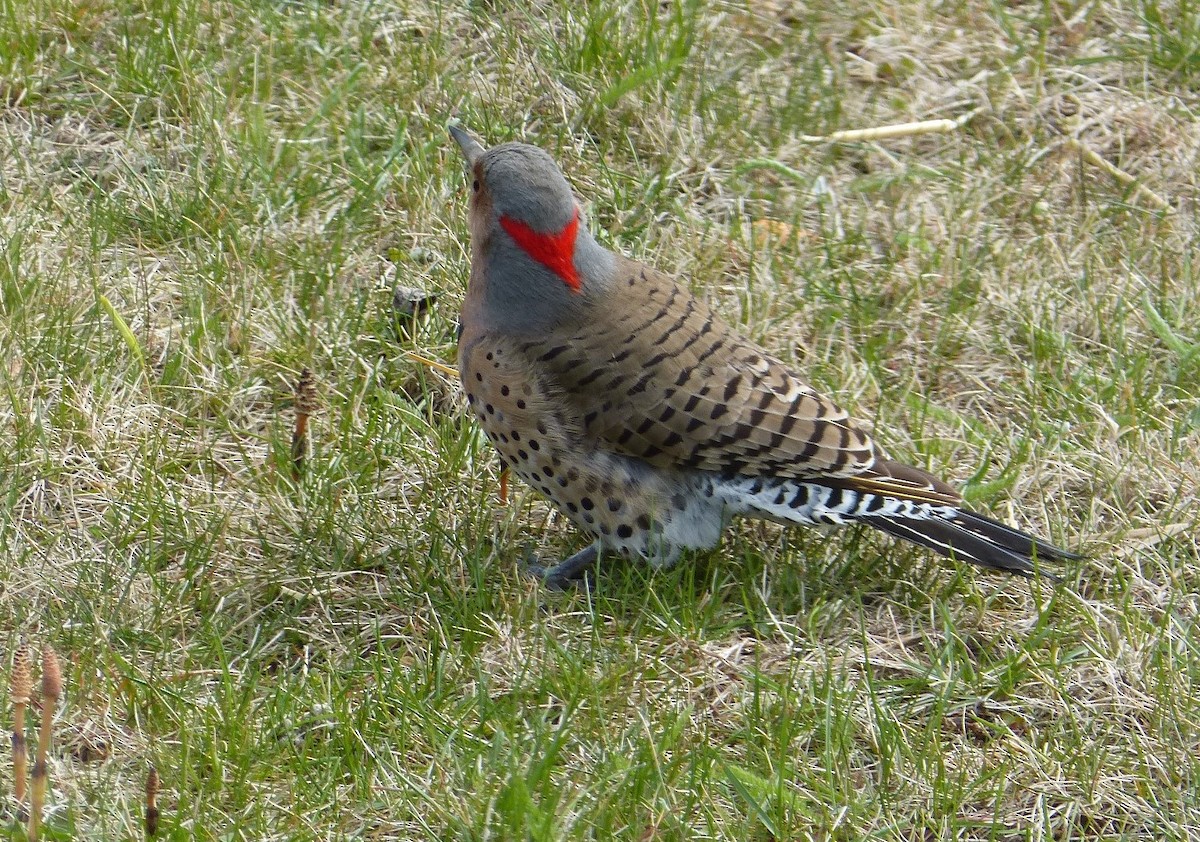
{"left": 450, "top": 126, "right": 1078, "bottom": 587}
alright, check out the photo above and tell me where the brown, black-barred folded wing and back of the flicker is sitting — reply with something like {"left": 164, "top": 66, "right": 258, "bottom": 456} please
{"left": 527, "top": 259, "right": 958, "bottom": 503}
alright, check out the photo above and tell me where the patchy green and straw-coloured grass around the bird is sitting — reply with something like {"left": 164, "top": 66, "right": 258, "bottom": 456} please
{"left": 0, "top": 0, "right": 1200, "bottom": 840}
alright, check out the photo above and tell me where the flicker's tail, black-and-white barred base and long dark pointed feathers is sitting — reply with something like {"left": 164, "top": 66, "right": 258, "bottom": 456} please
{"left": 720, "top": 463, "right": 1080, "bottom": 578}
